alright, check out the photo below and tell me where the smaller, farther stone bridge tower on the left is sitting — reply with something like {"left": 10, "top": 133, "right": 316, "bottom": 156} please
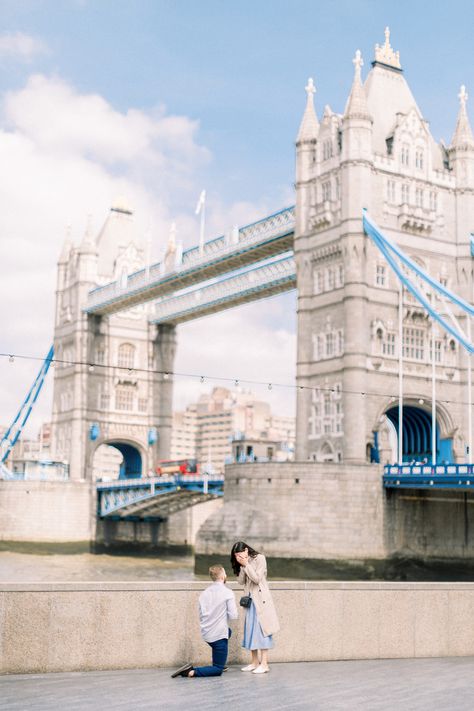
{"left": 52, "top": 201, "right": 175, "bottom": 480}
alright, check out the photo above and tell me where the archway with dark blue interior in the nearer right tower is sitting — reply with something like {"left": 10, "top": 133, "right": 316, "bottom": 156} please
{"left": 373, "top": 397, "right": 455, "bottom": 463}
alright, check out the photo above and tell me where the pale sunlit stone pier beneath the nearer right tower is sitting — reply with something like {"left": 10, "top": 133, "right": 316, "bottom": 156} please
{"left": 196, "top": 462, "right": 387, "bottom": 560}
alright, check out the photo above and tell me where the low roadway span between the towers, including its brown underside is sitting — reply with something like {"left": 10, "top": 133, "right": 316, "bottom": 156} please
{"left": 97, "top": 474, "right": 224, "bottom": 520}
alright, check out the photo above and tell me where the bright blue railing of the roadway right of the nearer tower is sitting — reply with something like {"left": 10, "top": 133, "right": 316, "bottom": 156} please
{"left": 383, "top": 464, "right": 474, "bottom": 489}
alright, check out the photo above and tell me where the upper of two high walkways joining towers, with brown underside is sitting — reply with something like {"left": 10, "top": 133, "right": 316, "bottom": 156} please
{"left": 85, "top": 207, "right": 295, "bottom": 315}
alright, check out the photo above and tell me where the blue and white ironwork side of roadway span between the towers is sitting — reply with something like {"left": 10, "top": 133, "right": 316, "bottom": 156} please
{"left": 97, "top": 474, "right": 224, "bottom": 518}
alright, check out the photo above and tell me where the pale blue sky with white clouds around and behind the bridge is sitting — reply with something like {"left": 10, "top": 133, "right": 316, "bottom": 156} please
{"left": 0, "top": 0, "right": 474, "bottom": 431}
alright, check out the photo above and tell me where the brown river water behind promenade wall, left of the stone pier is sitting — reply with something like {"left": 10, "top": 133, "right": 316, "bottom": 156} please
{"left": 0, "top": 551, "right": 202, "bottom": 583}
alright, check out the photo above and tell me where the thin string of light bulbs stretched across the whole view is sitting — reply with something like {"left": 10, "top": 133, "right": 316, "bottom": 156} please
{"left": 0, "top": 353, "right": 469, "bottom": 405}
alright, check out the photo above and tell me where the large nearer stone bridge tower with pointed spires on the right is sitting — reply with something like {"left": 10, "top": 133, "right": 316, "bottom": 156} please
{"left": 295, "top": 28, "right": 474, "bottom": 463}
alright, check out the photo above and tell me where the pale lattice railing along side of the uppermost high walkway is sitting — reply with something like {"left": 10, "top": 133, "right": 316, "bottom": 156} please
{"left": 87, "top": 206, "right": 295, "bottom": 308}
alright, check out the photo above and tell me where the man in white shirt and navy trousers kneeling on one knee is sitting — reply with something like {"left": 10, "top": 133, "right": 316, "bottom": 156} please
{"left": 171, "top": 565, "right": 239, "bottom": 678}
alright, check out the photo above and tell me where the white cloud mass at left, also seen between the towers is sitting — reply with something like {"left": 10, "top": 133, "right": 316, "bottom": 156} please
{"left": 0, "top": 75, "right": 295, "bottom": 440}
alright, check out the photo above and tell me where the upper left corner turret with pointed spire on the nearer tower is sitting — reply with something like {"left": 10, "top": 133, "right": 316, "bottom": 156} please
{"left": 296, "top": 77, "right": 319, "bottom": 235}
